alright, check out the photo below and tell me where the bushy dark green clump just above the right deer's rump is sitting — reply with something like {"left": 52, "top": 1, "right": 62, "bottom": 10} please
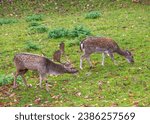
{"left": 68, "top": 26, "right": 91, "bottom": 37}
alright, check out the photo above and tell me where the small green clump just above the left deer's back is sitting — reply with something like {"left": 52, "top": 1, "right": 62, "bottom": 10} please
{"left": 25, "top": 41, "right": 40, "bottom": 50}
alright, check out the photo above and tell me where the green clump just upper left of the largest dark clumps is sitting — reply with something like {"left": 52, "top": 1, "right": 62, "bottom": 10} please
{"left": 29, "top": 25, "right": 48, "bottom": 33}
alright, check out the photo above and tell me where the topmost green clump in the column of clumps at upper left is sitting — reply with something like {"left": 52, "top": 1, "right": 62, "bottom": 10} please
{"left": 26, "top": 14, "right": 43, "bottom": 22}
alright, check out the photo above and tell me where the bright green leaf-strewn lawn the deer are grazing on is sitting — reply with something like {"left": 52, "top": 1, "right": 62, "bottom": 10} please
{"left": 0, "top": 1, "right": 150, "bottom": 106}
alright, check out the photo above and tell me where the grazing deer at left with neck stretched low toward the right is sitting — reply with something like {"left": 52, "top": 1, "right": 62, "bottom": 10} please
{"left": 14, "top": 53, "right": 78, "bottom": 88}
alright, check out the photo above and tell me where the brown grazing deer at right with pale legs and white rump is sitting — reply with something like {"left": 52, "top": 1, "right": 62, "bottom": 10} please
{"left": 80, "top": 37, "right": 134, "bottom": 69}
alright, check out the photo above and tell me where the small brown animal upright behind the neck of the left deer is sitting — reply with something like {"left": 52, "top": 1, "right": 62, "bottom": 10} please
{"left": 53, "top": 42, "right": 65, "bottom": 63}
